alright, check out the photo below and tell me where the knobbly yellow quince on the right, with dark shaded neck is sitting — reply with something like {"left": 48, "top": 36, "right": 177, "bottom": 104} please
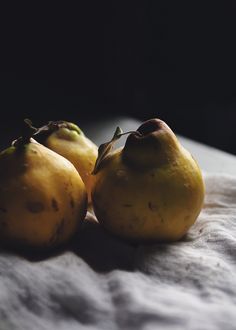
{"left": 92, "top": 119, "right": 205, "bottom": 241}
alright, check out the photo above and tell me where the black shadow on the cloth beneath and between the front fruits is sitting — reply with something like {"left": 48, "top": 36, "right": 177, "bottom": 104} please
{"left": 1, "top": 212, "right": 138, "bottom": 272}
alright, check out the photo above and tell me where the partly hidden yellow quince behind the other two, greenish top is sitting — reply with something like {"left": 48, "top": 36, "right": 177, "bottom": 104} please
{"left": 41, "top": 122, "right": 98, "bottom": 202}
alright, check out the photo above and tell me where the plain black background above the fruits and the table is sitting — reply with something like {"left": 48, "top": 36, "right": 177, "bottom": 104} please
{"left": 0, "top": 1, "right": 236, "bottom": 154}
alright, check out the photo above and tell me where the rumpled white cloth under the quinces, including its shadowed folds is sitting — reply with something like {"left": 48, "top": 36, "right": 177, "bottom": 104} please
{"left": 0, "top": 175, "right": 236, "bottom": 330}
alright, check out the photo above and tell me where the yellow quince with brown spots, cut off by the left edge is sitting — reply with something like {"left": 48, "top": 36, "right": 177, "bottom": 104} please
{"left": 0, "top": 139, "right": 87, "bottom": 248}
